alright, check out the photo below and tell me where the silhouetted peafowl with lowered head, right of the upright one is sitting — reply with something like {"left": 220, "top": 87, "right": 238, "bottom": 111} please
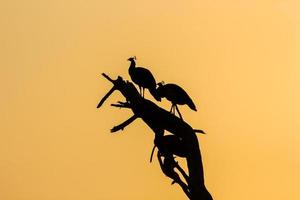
{"left": 157, "top": 82, "right": 197, "bottom": 119}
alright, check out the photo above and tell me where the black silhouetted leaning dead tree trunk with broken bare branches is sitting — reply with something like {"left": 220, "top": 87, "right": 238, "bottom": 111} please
{"left": 97, "top": 73, "right": 212, "bottom": 200}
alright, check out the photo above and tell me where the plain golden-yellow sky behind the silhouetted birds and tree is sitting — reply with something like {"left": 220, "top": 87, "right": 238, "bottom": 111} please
{"left": 0, "top": 0, "right": 300, "bottom": 200}
